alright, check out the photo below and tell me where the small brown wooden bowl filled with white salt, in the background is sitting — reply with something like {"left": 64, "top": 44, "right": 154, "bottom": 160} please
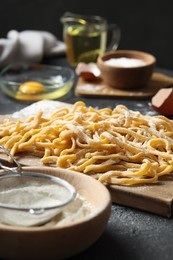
{"left": 97, "top": 50, "right": 156, "bottom": 89}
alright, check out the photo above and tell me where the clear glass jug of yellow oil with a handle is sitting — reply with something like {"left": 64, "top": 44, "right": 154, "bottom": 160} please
{"left": 60, "top": 12, "right": 120, "bottom": 67}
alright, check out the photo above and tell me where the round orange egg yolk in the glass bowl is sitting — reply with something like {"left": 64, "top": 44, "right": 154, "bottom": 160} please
{"left": 19, "top": 81, "right": 45, "bottom": 94}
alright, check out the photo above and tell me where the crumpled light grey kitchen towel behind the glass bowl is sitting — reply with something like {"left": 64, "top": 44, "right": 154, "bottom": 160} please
{"left": 0, "top": 30, "right": 65, "bottom": 67}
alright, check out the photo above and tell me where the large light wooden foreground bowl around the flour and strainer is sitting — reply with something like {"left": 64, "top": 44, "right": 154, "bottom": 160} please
{"left": 0, "top": 167, "right": 111, "bottom": 259}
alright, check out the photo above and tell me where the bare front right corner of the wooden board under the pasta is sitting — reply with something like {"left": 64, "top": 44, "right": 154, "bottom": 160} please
{"left": 108, "top": 174, "right": 173, "bottom": 218}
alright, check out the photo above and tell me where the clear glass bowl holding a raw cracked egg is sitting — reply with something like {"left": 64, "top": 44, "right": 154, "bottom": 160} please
{"left": 0, "top": 63, "right": 75, "bottom": 101}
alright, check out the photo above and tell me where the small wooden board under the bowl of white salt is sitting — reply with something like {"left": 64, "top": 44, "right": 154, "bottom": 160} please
{"left": 75, "top": 72, "right": 173, "bottom": 99}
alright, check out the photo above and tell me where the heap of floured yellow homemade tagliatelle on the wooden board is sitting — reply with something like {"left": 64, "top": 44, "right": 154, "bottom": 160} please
{"left": 0, "top": 102, "right": 173, "bottom": 185}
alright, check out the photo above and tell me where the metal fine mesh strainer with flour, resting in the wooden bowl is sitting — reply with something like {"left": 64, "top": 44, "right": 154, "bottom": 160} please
{"left": 0, "top": 146, "right": 76, "bottom": 226}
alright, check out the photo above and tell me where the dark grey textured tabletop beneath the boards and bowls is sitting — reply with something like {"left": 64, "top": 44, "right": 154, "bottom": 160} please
{"left": 0, "top": 57, "right": 173, "bottom": 260}
